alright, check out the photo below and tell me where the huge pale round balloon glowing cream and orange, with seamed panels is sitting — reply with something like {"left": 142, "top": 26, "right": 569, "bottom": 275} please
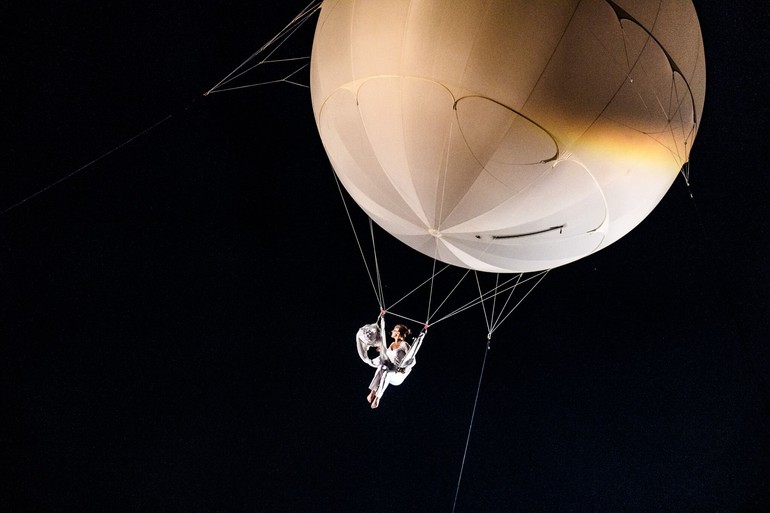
{"left": 311, "top": 0, "right": 706, "bottom": 272}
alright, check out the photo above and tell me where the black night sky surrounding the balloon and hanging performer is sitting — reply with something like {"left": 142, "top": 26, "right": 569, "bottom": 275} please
{"left": 0, "top": 1, "right": 770, "bottom": 513}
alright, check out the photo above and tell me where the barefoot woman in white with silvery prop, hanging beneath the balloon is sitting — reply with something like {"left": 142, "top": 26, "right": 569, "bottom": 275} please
{"left": 356, "top": 317, "right": 425, "bottom": 409}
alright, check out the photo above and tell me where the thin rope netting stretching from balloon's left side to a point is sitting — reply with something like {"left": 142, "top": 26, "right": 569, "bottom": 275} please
{"left": 204, "top": 1, "right": 323, "bottom": 96}
